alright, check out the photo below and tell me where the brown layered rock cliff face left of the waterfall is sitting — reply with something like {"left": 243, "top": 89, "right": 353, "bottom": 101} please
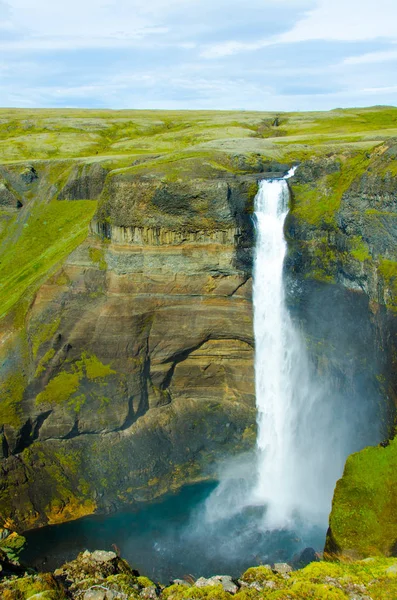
{"left": 0, "top": 157, "right": 262, "bottom": 529}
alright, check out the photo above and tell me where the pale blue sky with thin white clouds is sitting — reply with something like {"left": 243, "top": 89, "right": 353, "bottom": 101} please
{"left": 0, "top": 0, "right": 397, "bottom": 111}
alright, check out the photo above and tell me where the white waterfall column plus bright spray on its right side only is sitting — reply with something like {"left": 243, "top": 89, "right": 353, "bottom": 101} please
{"left": 253, "top": 170, "right": 341, "bottom": 528}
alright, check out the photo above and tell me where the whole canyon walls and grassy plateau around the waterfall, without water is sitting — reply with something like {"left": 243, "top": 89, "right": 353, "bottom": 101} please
{"left": 0, "top": 107, "right": 397, "bottom": 558}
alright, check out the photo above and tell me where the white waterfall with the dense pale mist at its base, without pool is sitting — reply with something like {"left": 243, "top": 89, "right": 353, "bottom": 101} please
{"left": 201, "top": 169, "right": 364, "bottom": 539}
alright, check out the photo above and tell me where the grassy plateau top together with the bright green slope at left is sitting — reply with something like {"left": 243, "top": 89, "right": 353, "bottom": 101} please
{"left": 0, "top": 107, "right": 397, "bottom": 326}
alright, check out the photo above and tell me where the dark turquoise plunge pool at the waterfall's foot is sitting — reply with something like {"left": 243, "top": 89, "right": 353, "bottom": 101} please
{"left": 22, "top": 483, "right": 325, "bottom": 584}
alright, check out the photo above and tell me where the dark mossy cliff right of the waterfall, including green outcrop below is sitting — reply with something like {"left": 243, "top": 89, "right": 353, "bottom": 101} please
{"left": 287, "top": 142, "right": 397, "bottom": 557}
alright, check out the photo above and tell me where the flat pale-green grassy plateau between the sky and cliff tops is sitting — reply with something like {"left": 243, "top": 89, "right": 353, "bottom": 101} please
{"left": 0, "top": 107, "right": 397, "bottom": 167}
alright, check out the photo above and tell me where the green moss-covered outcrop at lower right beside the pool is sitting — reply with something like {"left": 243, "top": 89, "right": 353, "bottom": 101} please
{"left": 326, "top": 438, "right": 397, "bottom": 556}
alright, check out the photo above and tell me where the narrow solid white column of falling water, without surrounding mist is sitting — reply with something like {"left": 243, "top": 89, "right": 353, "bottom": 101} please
{"left": 253, "top": 168, "right": 299, "bottom": 526}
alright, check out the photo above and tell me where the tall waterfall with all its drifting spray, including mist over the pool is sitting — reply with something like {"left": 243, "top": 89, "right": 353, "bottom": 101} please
{"left": 179, "top": 171, "right": 379, "bottom": 573}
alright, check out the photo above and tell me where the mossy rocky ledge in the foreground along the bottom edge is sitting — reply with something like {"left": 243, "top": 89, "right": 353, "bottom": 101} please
{"left": 0, "top": 530, "right": 397, "bottom": 600}
